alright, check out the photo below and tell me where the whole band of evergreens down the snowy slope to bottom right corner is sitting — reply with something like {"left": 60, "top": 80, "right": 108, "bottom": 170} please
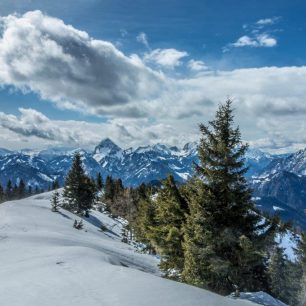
{"left": 55, "top": 101, "right": 306, "bottom": 306}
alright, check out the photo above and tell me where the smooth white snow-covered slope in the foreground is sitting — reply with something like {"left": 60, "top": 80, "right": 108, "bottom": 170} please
{"left": 0, "top": 193, "right": 280, "bottom": 306}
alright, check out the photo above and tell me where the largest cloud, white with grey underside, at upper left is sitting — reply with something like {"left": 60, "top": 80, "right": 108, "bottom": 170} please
{"left": 0, "top": 11, "right": 162, "bottom": 117}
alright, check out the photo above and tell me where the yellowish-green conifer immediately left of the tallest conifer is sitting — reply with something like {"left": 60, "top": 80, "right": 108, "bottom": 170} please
{"left": 151, "top": 175, "right": 187, "bottom": 279}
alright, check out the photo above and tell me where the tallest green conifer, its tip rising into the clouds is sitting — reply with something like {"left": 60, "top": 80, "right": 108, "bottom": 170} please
{"left": 182, "top": 100, "right": 273, "bottom": 294}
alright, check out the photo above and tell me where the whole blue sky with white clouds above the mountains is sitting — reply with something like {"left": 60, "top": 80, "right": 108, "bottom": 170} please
{"left": 0, "top": 0, "right": 306, "bottom": 153}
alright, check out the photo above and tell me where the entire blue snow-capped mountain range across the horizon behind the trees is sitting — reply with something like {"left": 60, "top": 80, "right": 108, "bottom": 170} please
{"left": 0, "top": 138, "right": 306, "bottom": 229}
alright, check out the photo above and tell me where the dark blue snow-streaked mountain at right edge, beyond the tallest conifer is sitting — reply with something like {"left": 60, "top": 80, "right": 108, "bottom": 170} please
{"left": 250, "top": 149, "right": 306, "bottom": 228}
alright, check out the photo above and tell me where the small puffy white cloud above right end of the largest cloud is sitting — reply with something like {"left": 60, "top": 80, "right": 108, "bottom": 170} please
{"left": 144, "top": 48, "right": 188, "bottom": 68}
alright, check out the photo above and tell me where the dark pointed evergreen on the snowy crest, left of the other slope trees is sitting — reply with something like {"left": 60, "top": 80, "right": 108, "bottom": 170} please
{"left": 63, "top": 153, "right": 95, "bottom": 215}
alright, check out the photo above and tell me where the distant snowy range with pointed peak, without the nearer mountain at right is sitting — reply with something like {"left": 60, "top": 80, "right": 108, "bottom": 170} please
{"left": 0, "top": 138, "right": 272, "bottom": 189}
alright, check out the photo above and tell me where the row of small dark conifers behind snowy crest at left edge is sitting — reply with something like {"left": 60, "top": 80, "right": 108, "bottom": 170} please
{"left": 0, "top": 179, "right": 44, "bottom": 203}
